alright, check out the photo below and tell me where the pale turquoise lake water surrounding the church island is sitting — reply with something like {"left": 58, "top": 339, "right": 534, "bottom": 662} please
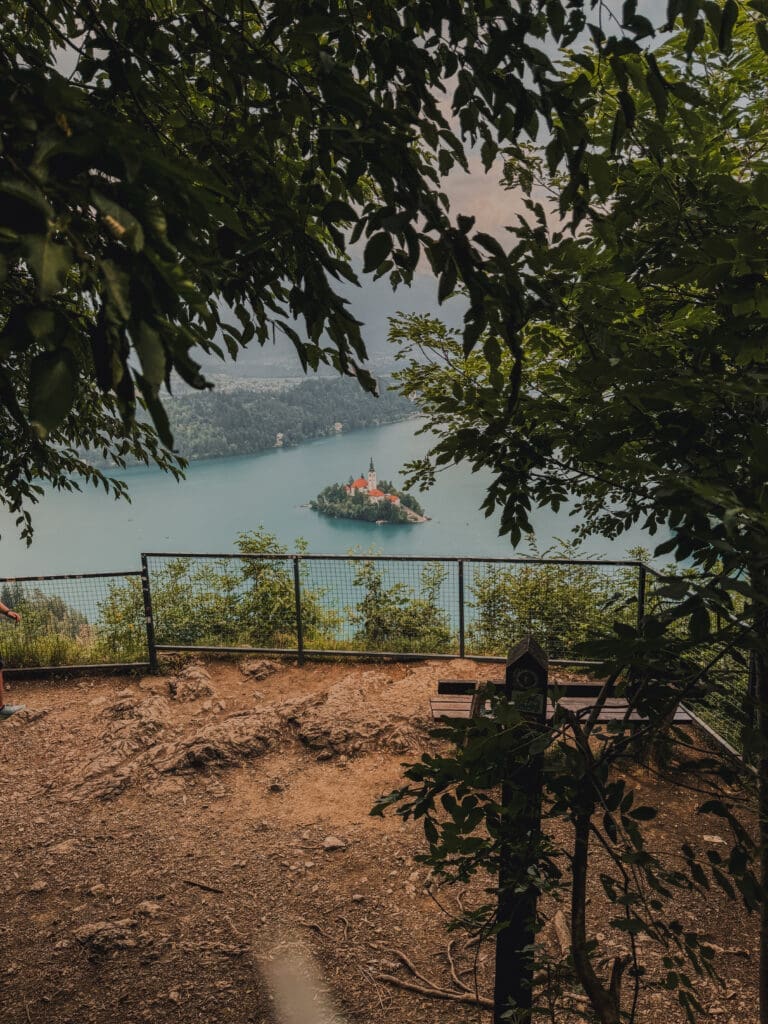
{"left": 0, "top": 420, "right": 657, "bottom": 577}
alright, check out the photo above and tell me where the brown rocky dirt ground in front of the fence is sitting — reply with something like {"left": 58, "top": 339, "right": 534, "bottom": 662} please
{"left": 0, "top": 660, "right": 757, "bottom": 1024}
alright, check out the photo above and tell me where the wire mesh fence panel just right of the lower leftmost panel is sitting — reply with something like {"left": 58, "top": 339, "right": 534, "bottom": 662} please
{"left": 145, "top": 554, "right": 298, "bottom": 650}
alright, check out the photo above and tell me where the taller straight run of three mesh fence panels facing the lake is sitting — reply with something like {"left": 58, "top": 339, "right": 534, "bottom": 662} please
{"left": 142, "top": 553, "right": 645, "bottom": 664}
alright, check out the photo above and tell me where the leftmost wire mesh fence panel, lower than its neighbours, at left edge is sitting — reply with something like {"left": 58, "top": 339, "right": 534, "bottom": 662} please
{"left": 0, "top": 572, "right": 147, "bottom": 669}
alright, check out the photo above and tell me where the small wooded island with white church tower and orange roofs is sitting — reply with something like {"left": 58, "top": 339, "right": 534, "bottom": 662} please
{"left": 309, "top": 459, "right": 428, "bottom": 525}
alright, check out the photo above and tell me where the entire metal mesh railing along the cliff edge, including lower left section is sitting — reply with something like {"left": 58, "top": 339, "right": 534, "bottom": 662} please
{"left": 0, "top": 552, "right": 748, "bottom": 761}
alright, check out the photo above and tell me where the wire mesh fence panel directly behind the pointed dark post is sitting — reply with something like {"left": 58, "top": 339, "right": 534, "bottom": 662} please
{"left": 465, "top": 559, "right": 641, "bottom": 663}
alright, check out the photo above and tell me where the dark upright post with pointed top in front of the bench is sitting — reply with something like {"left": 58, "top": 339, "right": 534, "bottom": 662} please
{"left": 494, "top": 638, "right": 548, "bottom": 1024}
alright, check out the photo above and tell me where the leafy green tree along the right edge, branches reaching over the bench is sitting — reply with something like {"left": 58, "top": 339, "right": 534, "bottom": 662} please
{"left": 385, "top": 24, "right": 768, "bottom": 1024}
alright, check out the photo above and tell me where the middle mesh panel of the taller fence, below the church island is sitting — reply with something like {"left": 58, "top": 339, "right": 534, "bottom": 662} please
{"left": 300, "top": 556, "right": 459, "bottom": 654}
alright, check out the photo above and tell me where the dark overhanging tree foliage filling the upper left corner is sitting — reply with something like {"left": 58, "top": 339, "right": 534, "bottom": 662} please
{"left": 0, "top": 0, "right": 720, "bottom": 537}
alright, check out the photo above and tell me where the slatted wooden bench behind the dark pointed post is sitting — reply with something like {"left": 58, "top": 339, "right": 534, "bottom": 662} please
{"left": 429, "top": 679, "right": 691, "bottom": 725}
